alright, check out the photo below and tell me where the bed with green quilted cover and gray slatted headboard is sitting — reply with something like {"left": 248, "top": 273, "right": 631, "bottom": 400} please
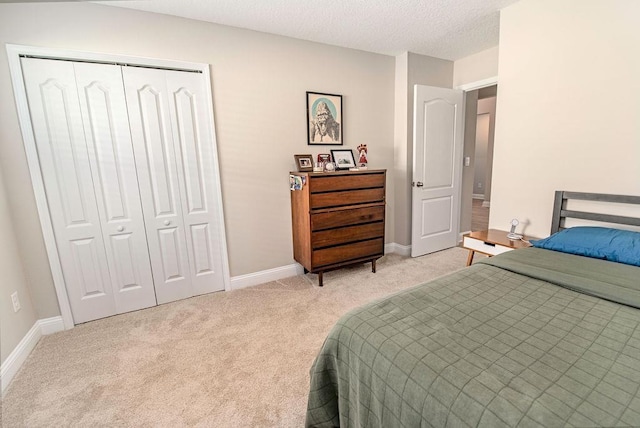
{"left": 306, "top": 192, "right": 640, "bottom": 428}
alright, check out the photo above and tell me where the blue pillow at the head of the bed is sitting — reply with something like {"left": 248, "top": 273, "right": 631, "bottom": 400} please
{"left": 531, "top": 226, "right": 640, "bottom": 266}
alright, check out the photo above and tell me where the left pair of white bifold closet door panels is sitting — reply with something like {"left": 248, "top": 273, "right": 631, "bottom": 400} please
{"left": 21, "top": 58, "right": 156, "bottom": 324}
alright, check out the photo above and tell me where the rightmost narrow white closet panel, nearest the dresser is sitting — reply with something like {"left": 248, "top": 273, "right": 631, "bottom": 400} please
{"left": 164, "top": 71, "right": 224, "bottom": 294}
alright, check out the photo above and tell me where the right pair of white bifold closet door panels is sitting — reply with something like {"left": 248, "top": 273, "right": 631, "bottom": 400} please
{"left": 123, "top": 67, "right": 224, "bottom": 303}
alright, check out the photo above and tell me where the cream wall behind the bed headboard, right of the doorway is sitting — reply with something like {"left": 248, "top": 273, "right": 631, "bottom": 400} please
{"left": 490, "top": 0, "right": 640, "bottom": 236}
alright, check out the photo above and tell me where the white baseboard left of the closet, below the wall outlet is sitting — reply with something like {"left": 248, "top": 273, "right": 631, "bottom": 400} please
{"left": 0, "top": 316, "right": 64, "bottom": 396}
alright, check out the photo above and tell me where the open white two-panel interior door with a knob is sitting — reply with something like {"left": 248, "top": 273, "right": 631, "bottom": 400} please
{"left": 411, "top": 85, "right": 464, "bottom": 257}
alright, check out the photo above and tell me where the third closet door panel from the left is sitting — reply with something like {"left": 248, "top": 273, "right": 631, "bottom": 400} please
{"left": 122, "top": 67, "right": 193, "bottom": 303}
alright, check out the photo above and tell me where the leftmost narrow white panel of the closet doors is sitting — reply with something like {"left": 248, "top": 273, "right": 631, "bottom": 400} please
{"left": 21, "top": 58, "right": 116, "bottom": 324}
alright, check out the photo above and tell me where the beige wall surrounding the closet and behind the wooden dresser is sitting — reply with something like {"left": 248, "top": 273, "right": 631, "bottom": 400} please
{"left": 0, "top": 3, "right": 395, "bottom": 318}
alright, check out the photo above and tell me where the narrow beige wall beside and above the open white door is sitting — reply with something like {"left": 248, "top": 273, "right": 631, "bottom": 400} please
{"left": 394, "top": 53, "right": 453, "bottom": 245}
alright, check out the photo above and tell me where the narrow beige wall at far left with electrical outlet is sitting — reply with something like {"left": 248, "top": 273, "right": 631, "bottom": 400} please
{"left": 0, "top": 174, "right": 37, "bottom": 363}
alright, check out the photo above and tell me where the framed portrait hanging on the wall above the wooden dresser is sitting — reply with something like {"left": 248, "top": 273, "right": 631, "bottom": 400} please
{"left": 307, "top": 92, "right": 343, "bottom": 146}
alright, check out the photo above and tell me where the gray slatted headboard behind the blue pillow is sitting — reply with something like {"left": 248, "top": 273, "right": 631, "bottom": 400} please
{"left": 551, "top": 190, "right": 640, "bottom": 234}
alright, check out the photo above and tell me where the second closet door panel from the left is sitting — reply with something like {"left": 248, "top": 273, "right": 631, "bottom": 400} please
{"left": 74, "top": 63, "right": 156, "bottom": 313}
